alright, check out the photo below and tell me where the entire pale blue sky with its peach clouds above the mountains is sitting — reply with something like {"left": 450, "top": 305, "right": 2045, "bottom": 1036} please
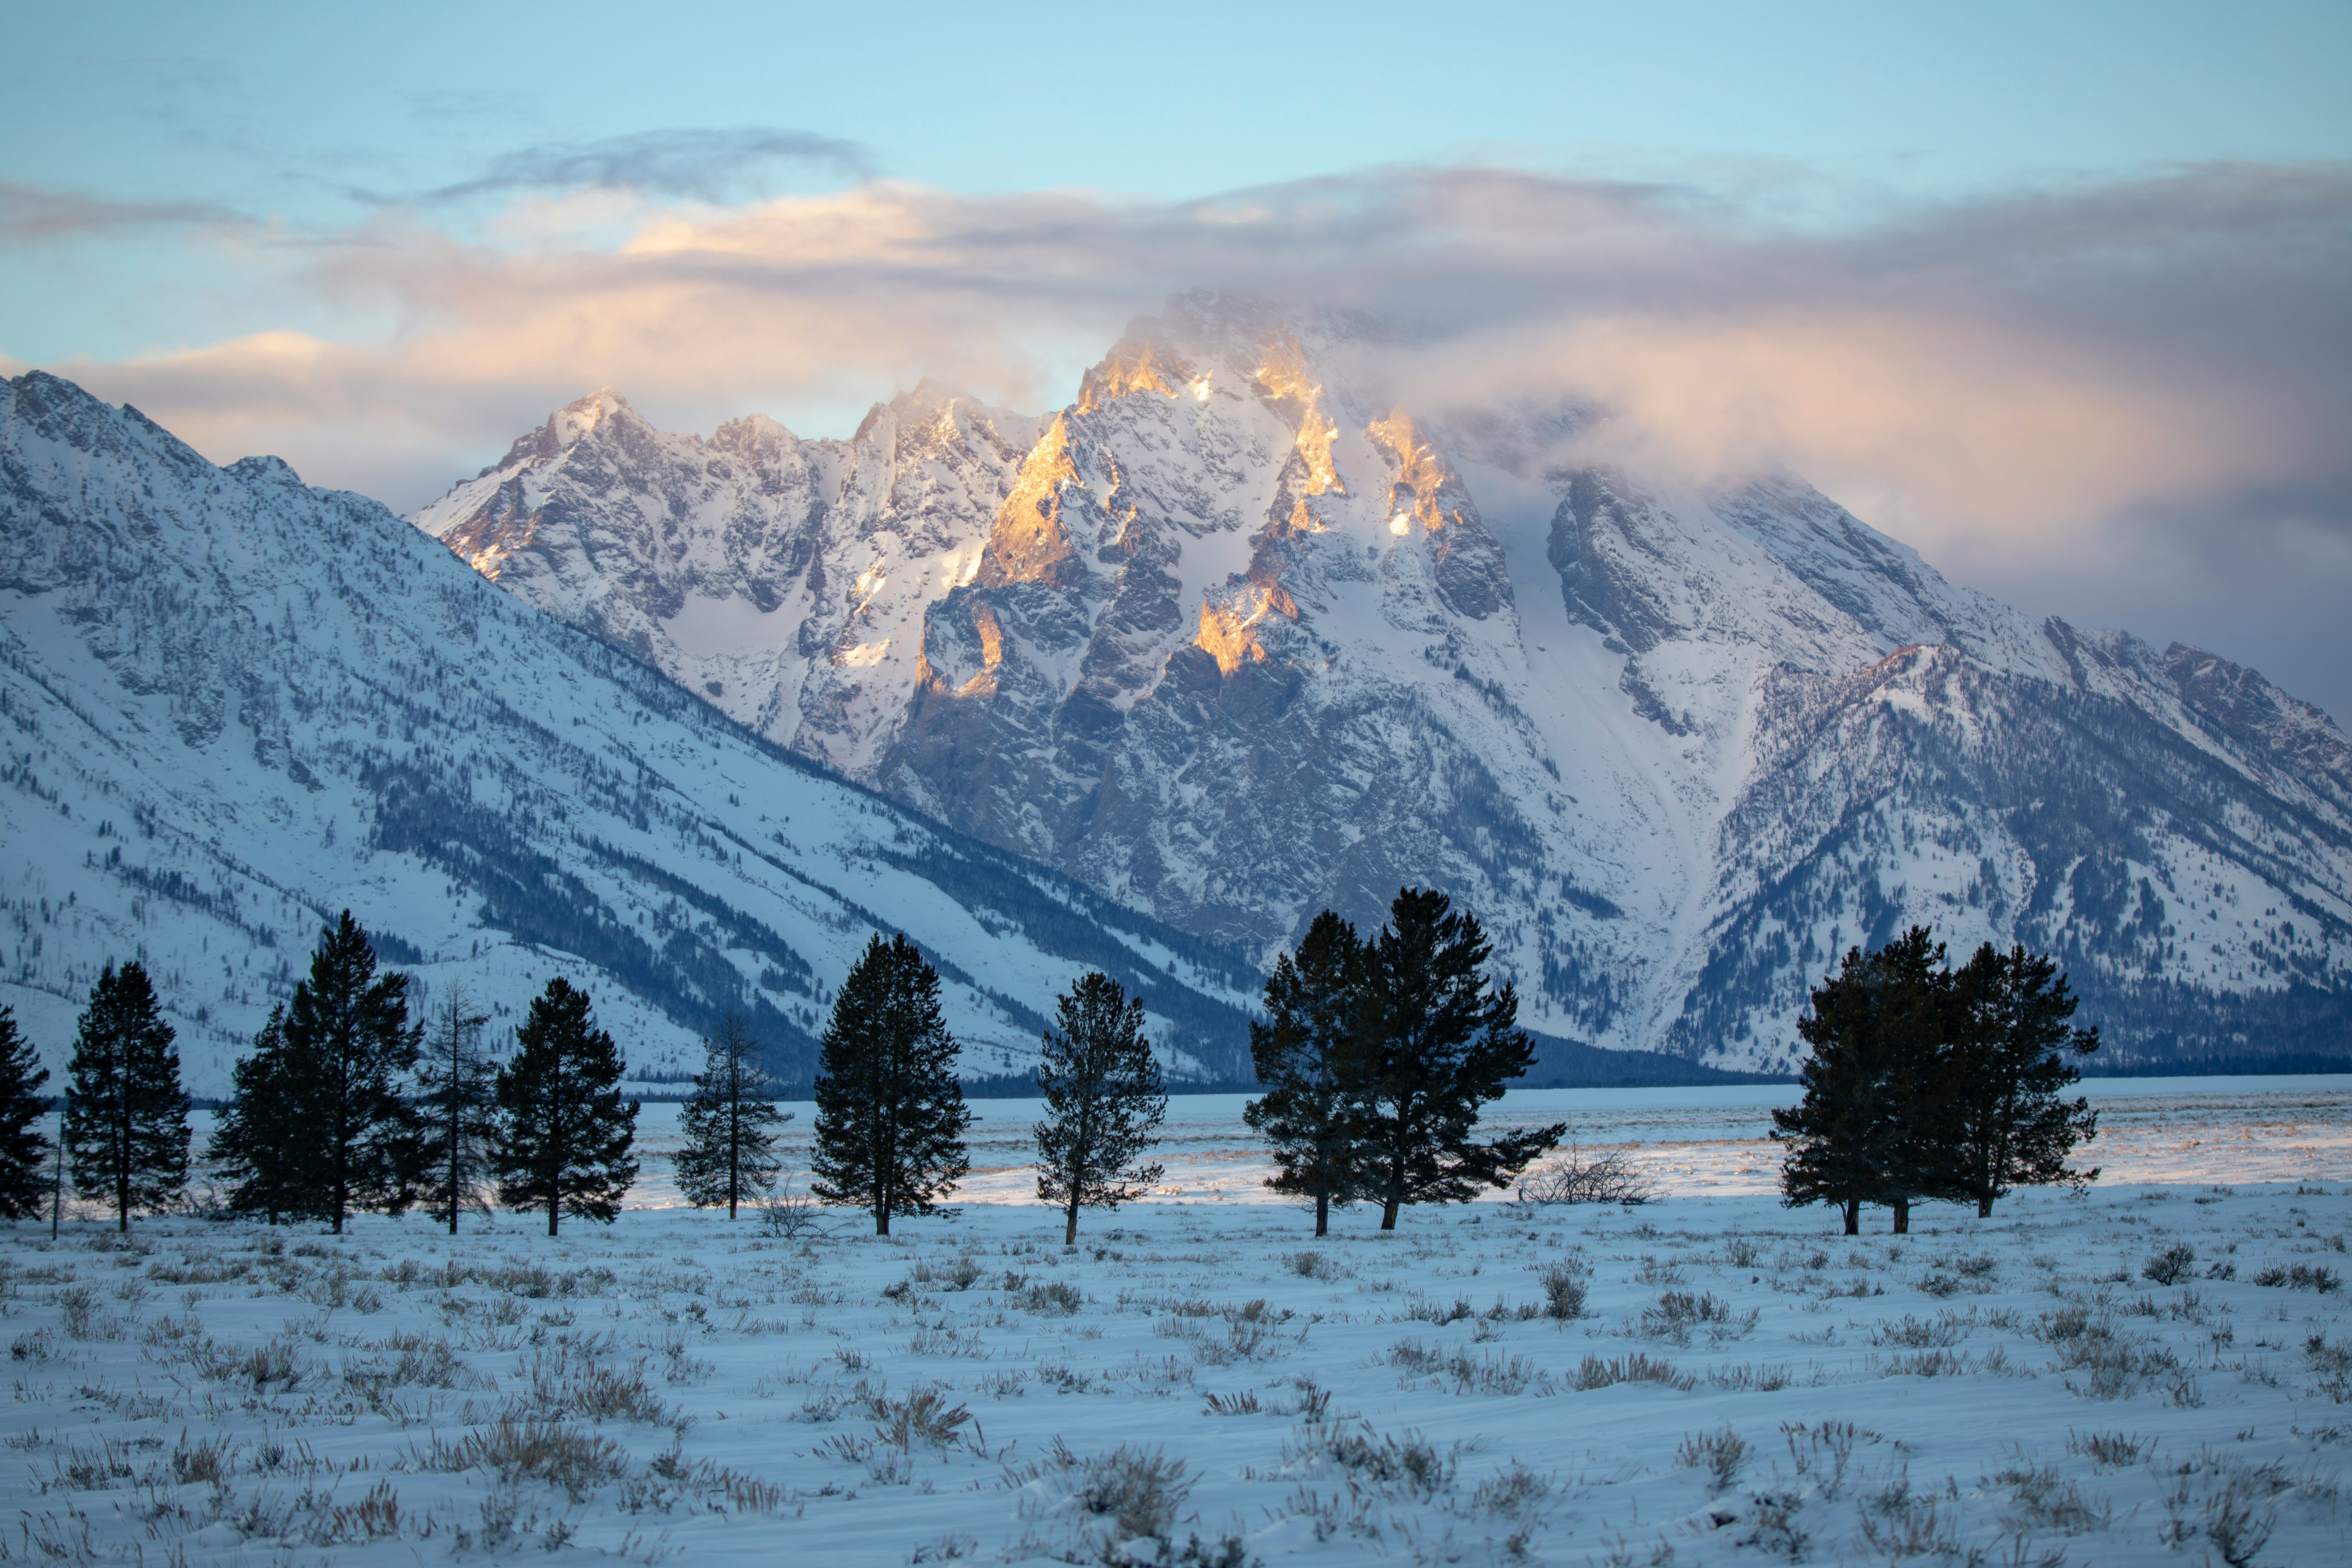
{"left": 0, "top": 2, "right": 2352, "bottom": 715}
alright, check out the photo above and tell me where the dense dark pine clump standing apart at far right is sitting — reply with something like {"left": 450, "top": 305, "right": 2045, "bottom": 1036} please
{"left": 1771, "top": 926, "right": 2098, "bottom": 1237}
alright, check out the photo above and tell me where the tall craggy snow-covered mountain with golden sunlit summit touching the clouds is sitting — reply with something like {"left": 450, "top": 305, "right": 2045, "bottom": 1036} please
{"left": 414, "top": 296, "right": 2352, "bottom": 1065}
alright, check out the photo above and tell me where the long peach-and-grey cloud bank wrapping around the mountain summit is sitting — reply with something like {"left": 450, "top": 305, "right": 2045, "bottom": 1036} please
{"left": 32, "top": 158, "right": 2352, "bottom": 703}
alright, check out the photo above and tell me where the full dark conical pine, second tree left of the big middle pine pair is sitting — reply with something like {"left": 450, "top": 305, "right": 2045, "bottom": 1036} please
{"left": 809, "top": 933, "right": 971, "bottom": 1237}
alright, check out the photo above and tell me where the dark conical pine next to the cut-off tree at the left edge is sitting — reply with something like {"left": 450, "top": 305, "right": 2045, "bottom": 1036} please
{"left": 63, "top": 961, "right": 188, "bottom": 1232}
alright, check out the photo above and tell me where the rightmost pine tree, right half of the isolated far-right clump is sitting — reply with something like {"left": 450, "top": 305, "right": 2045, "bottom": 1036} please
{"left": 1940, "top": 943, "right": 2098, "bottom": 1220}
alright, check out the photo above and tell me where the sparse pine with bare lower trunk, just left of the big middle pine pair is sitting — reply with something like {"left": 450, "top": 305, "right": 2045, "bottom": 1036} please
{"left": 1032, "top": 971, "right": 1169, "bottom": 1246}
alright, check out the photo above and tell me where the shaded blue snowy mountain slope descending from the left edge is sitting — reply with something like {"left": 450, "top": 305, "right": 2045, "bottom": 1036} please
{"left": 0, "top": 374, "right": 1256, "bottom": 1093}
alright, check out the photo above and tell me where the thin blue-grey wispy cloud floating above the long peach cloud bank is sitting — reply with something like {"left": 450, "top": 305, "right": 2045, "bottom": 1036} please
{"left": 424, "top": 125, "right": 873, "bottom": 202}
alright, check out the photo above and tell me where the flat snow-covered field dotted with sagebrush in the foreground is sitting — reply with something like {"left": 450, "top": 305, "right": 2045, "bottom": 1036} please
{"left": 0, "top": 1079, "right": 2352, "bottom": 1566}
